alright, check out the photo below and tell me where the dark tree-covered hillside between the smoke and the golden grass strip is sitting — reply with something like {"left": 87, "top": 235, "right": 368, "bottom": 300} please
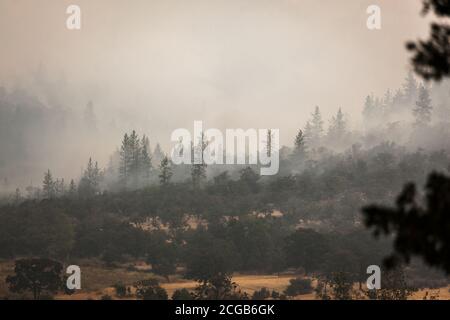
{"left": 0, "top": 138, "right": 450, "bottom": 288}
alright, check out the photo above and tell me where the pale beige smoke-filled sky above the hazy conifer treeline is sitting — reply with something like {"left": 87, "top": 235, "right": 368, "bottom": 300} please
{"left": 0, "top": 0, "right": 428, "bottom": 147}
